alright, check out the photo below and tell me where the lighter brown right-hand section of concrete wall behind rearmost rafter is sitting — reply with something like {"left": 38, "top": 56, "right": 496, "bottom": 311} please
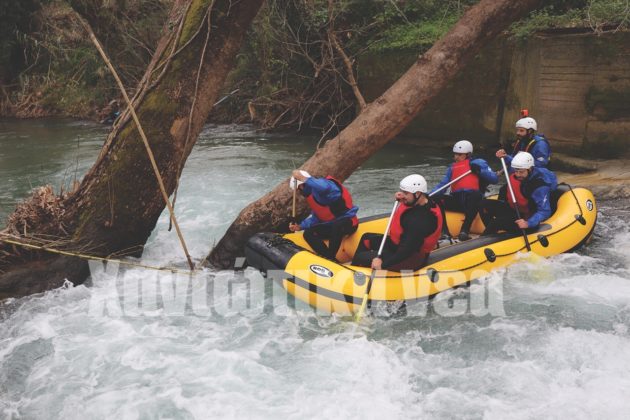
{"left": 501, "top": 32, "right": 630, "bottom": 155}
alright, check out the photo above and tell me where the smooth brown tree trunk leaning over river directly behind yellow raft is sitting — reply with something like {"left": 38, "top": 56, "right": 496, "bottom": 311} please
{"left": 208, "top": 0, "right": 541, "bottom": 268}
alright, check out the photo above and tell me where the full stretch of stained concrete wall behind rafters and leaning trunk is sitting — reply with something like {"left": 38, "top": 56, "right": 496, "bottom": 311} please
{"left": 359, "top": 32, "right": 630, "bottom": 157}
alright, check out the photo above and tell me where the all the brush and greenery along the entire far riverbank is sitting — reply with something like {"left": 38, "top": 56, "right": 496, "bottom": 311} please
{"left": 0, "top": 0, "right": 630, "bottom": 133}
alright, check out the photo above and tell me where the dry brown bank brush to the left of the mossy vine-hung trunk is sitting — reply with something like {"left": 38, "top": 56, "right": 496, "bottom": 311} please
{"left": 0, "top": 0, "right": 171, "bottom": 119}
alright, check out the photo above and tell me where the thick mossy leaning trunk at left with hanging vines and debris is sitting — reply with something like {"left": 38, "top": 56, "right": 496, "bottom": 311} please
{"left": 0, "top": 0, "right": 263, "bottom": 299}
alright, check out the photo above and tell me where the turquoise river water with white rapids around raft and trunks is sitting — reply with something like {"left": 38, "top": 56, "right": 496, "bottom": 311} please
{"left": 0, "top": 120, "right": 630, "bottom": 419}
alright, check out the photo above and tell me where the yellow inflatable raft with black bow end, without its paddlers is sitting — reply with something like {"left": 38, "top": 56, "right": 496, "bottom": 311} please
{"left": 245, "top": 184, "right": 597, "bottom": 315}
